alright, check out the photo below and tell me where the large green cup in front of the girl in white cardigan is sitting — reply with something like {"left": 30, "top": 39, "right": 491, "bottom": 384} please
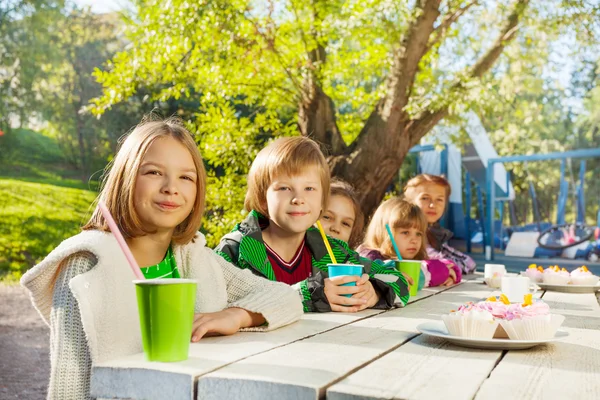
{"left": 133, "top": 279, "right": 196, "bottom": 362}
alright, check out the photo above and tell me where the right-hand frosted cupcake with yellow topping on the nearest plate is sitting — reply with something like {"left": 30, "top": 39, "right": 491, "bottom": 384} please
{"left": 500, "top": 294, "right": 565, "bottom": 340}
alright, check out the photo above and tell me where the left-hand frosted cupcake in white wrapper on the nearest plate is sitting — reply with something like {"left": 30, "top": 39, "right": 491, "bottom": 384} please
{"left": 442, "top": 302, "right": 498, "bottom": 339}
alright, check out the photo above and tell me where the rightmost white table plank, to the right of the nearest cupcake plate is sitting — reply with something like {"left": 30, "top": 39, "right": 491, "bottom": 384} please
{"left": 476, "top": 291, "right": 600, "bottom": 400}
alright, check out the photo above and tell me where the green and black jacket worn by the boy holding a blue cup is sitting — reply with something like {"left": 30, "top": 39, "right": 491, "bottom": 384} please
{"left": 215, "top": 211, "right": 409, "bottom": 312}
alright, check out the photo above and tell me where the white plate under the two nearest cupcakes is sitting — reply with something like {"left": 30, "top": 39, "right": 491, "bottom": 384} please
{"left": 417, "top": 321, "right": 569, "bottom": 350}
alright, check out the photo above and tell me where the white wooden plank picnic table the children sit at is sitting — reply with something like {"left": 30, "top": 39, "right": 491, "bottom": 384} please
{"left": 91, "top": 276, "right": 600, "bottom": 400}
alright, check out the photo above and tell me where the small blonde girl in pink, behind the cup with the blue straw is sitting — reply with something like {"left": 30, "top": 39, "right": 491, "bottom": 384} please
{"left": 358, "top": 197, "right": 461, "bottom": 288}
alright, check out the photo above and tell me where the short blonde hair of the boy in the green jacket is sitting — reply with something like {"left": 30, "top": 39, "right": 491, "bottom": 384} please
{"left": 244, "top": 136, "right": 330, "bottom": 216}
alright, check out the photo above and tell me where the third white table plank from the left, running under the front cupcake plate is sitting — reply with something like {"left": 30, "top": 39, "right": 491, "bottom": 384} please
{"left": 327, "top": 281, "right": 502, "bottom": 399}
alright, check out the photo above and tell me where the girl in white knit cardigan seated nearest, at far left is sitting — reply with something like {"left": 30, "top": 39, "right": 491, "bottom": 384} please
{"left": 21, "top": 120, "right": 302, "bottom": 399}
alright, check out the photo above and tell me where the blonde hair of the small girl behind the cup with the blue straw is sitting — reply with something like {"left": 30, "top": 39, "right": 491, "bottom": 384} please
{"left": 363, "top": 197, "right": 427, "bottom": 260}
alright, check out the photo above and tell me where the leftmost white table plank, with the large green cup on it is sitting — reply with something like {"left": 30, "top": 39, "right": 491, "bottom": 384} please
{"left": 91, "top": 310, "right": 382, "bottom": 400}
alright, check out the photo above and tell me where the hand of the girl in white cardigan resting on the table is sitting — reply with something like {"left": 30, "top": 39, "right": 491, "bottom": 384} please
{"left": 192, "top": 308, "right": 265, "bottom": 342}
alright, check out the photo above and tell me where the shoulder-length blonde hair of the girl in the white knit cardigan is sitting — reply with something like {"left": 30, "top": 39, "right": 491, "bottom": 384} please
{"left": 83, "top": 117, "right": 206, "bottom": 244}
